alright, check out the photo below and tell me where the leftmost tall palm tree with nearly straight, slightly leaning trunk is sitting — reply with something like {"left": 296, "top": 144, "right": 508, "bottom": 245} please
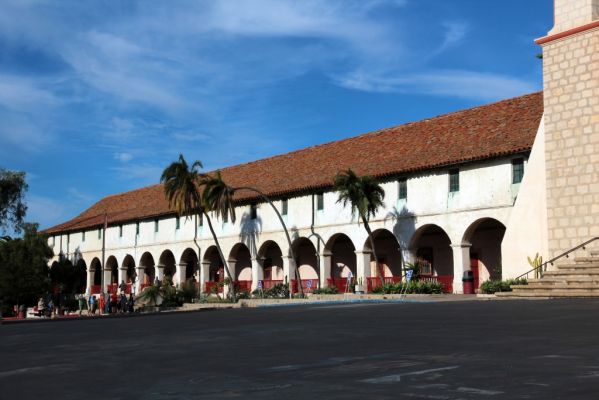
{"left": 160, "top": 154, "right": 235, "bottom": 299}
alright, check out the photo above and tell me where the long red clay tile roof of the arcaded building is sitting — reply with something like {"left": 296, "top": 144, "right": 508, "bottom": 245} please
{"left": 45, "top": 92, "right": 543, "bottom": 234}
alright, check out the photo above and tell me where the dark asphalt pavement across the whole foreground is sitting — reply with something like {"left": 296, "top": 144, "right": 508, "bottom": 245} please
{"left": 0, "top": 300, "right": 599, "bottom": 400}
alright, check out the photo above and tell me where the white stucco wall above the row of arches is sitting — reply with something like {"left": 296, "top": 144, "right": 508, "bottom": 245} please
{"left": 50, "top": 157, "right": 536, "bottom": 292}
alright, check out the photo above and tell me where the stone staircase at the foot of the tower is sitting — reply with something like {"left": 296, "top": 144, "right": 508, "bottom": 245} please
{"left": 496, "top": 250, "right": 599, "bottom": 298}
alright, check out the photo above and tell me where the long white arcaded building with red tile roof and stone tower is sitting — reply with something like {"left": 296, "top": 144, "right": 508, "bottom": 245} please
{"left": 46, "top": 0, "right": 599, "bottom": 293}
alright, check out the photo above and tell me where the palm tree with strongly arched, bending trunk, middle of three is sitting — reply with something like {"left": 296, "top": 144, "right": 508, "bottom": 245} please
{"left": 202, "top": 171, "right": 304, "bottom": 296}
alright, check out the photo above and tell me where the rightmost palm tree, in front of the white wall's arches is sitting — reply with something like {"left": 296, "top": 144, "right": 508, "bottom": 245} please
{"left": 334, "top": 168, "right": 385, "bottom": 277}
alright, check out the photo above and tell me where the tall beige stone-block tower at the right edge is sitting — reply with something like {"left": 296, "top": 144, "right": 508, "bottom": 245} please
{"left": 537, "top": 0, "right": 599, "bottom": 257}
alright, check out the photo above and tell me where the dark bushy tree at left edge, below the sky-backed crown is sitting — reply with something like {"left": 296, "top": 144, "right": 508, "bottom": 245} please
{"left": 0, "top": 224, "right": 53, "bottom": 314}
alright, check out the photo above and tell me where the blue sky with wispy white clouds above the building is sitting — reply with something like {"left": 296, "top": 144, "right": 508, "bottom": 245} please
{"left": 0, "top": 0, "right": 553, "bottom": 227}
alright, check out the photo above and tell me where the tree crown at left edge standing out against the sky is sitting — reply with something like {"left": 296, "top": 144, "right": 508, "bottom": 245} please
{"left": 0, "top": 168, "right": 28, "bottom": 233}
